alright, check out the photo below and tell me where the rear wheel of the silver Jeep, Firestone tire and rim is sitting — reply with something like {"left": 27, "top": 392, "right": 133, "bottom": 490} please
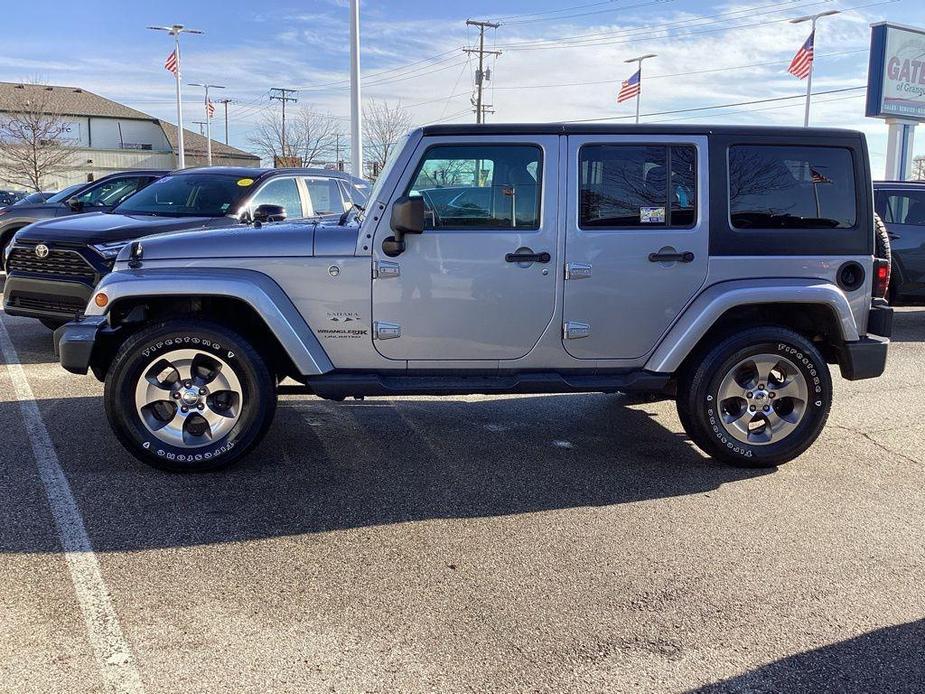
{"left": 677, "top": 326, "right": 832, "bottom": 468}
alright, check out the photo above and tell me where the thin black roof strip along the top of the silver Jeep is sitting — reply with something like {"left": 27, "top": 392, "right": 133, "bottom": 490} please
{"left": 421, "top": 123, "right": 860, "bottom": 137}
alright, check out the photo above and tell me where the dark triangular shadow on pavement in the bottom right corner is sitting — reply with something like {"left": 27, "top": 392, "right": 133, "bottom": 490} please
{"left": 694, "top": 620, "right": 925, "bottom": 694}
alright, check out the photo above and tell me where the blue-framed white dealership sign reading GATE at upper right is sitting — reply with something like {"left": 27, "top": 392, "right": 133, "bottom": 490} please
{"left": 867, "top": 23, "right": 925, "bottom": 121}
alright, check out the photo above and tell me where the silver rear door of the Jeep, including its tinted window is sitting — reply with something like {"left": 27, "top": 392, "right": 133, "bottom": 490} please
{"left": 563, "top": 135, "right": 709, "bottom": 359}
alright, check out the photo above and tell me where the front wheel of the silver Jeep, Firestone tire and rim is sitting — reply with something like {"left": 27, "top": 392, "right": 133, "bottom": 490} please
{"left": 104, "top": 319, "right": 276, "bottom": 472}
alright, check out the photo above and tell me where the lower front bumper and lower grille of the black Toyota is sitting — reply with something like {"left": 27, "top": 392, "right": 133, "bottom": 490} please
{"left": 3, "top": 273, "right": 93, "bottom": 321}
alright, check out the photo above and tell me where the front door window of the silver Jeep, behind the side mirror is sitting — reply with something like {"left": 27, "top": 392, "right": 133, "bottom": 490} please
{"left": 406, "top": 145, "right": 543, "bottom": 229}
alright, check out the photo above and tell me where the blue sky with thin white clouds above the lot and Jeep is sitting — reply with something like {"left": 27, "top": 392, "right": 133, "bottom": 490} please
{"left": 0, "top": 0, "right": 925, "bottom": 175}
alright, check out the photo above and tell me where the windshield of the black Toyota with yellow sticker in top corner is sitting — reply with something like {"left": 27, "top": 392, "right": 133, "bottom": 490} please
{"left": 113, "top": 173, "right": 254, "bottom": 217}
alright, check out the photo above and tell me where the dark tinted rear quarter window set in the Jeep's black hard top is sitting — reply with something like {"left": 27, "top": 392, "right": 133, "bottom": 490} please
{"left": 729, "top": 145, "right": 857, "bottom": 229}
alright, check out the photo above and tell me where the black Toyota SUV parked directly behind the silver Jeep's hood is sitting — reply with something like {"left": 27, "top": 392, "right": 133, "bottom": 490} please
{"left": 4, "top": 167, "right": 372, "bottom": 328}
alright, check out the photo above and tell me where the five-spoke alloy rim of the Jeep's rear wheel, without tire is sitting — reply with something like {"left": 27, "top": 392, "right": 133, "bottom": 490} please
{"left": 716, "top": 354, "right": 809, "bottom": 446}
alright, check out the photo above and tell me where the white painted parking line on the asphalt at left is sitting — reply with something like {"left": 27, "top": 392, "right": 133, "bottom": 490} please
{"left": 0, "top": 320, "right": 144, "bottom": 693}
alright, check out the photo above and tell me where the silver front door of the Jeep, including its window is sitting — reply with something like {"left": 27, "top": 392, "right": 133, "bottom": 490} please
{"left": 372, "top": 135, "right": 559, "bottom": 361}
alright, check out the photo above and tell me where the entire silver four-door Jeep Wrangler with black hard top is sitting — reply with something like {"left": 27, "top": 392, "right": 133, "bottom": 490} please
{"left": 55, "top": 124, "right": 892, "bottom": 471}
